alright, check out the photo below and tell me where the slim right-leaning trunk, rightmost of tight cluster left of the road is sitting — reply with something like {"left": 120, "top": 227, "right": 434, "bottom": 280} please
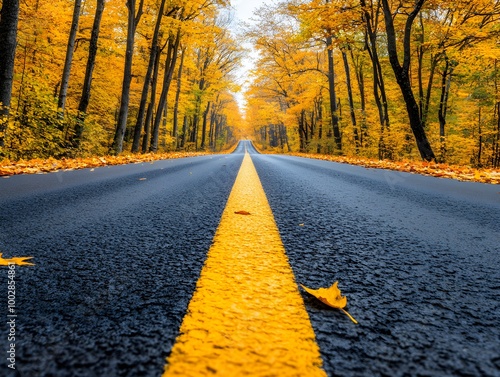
{"left": 149, "top": 29, "right": 181, "bottom": 152}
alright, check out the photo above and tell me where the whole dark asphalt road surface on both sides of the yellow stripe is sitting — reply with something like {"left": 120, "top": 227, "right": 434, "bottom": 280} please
{"left": 0, "top": 143, "right": 500, "bottom": 377}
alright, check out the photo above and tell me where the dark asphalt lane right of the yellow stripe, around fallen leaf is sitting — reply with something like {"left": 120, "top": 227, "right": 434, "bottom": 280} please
{"left": 252, "top": 149, "right": 500, "bottom": 376}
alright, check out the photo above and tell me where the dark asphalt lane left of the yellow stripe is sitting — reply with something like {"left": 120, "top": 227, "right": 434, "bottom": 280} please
{"left": 0, "top": 148, "right": 243, "bottom": 377}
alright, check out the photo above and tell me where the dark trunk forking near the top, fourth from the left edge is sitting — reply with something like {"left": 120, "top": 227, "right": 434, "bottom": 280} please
{"left": 111, "top": 0, "right": 144, "bottom": 154}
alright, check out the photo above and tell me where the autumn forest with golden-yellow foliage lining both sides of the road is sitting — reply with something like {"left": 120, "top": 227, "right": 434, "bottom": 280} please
{"left": 0, "top": 0, "right": 500, "bottom": 168}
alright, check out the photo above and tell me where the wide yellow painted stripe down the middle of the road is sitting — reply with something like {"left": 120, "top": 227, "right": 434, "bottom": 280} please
{"left": 163, "top": 153, "right": 326, "bottom": 377}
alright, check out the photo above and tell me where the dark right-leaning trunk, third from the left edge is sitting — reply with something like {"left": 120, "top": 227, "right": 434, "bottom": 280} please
{"left": 73, "top": 0, "right": 106, "bottom": 148}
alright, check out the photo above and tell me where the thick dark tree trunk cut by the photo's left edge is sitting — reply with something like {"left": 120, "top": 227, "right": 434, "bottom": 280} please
{"left": 0, "top": 0, "right": 19, "bottom": 147}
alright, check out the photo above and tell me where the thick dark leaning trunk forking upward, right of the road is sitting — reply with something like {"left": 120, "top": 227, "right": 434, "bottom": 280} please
{"left": 382, "top": 0, "right": 436, "bottom": 161}
